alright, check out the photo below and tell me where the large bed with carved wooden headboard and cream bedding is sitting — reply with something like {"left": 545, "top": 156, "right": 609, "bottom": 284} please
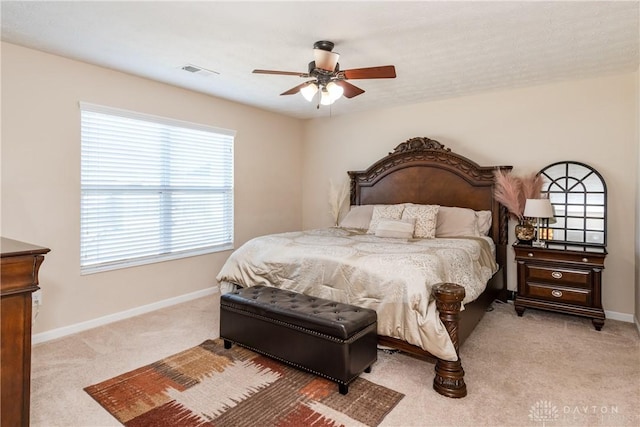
{"left": 217, "top": 137, "right": 511, "bottom": 397}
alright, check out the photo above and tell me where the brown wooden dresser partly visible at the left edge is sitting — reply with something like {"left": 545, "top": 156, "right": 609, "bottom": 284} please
{"left": 0, "top": 237, "right": 49, "bottom": 427}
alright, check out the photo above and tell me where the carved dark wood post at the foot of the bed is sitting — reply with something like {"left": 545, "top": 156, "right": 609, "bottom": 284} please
{"left": 433, "top": 283, "right": 467, "bottom": 397}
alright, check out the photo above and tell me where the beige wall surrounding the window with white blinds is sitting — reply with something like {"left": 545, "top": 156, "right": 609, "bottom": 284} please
{"left": 1, "top": 43, "right": 303, "bottom": 333}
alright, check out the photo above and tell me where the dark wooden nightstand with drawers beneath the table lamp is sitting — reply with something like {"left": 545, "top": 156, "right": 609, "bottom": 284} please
{"left": 513, "top": 244, "right": 607, "bottom": 331}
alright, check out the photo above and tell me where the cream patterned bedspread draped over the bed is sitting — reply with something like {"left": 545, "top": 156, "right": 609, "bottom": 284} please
{"left": 217, "top": 228, "right": 497, "bottom": 360}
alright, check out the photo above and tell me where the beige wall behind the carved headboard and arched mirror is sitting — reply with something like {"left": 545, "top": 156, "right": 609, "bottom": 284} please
{"left": 302, "top": 72, "right": 638, "bottom": 315}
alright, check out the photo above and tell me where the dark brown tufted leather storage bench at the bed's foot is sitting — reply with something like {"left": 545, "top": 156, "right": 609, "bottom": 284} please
{"left": 220, "top": 286, "right": 378, "bottom": 394}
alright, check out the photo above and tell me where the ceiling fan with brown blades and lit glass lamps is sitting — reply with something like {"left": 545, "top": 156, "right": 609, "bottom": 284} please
{"left": 253, "top": 40, "right": 396, "bottom": 108}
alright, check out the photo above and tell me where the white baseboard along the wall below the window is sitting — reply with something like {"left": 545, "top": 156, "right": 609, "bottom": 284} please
{"left": 31, "top": 286, "right": 220, "bottom": 344}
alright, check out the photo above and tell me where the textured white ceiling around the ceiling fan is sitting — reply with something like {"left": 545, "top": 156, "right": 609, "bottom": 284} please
{"left": 1, "top": 1, "right": 640, "bottom": 118}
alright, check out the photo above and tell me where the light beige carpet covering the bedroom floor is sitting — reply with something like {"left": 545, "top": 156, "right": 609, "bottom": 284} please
{"left": 31, "top": 297, "right": 640, "bottom": 426}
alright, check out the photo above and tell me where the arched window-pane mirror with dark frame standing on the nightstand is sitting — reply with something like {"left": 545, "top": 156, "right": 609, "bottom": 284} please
{"left": 540, "top": 161, "right": 607, "bottom": 251}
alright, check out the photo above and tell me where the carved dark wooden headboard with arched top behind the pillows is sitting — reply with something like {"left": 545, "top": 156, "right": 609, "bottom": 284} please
{"left": 348, "top": 137, "right": 512, "bottom": 283}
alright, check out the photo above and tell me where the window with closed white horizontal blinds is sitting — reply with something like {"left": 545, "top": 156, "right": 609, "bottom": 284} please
{"left": 80, "top": 103, "right": 235, "bottom": 274}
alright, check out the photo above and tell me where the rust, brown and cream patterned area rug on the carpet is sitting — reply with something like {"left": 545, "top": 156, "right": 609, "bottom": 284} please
{"left": 85, "top": 339, "right": 404, "bottom": 427}
